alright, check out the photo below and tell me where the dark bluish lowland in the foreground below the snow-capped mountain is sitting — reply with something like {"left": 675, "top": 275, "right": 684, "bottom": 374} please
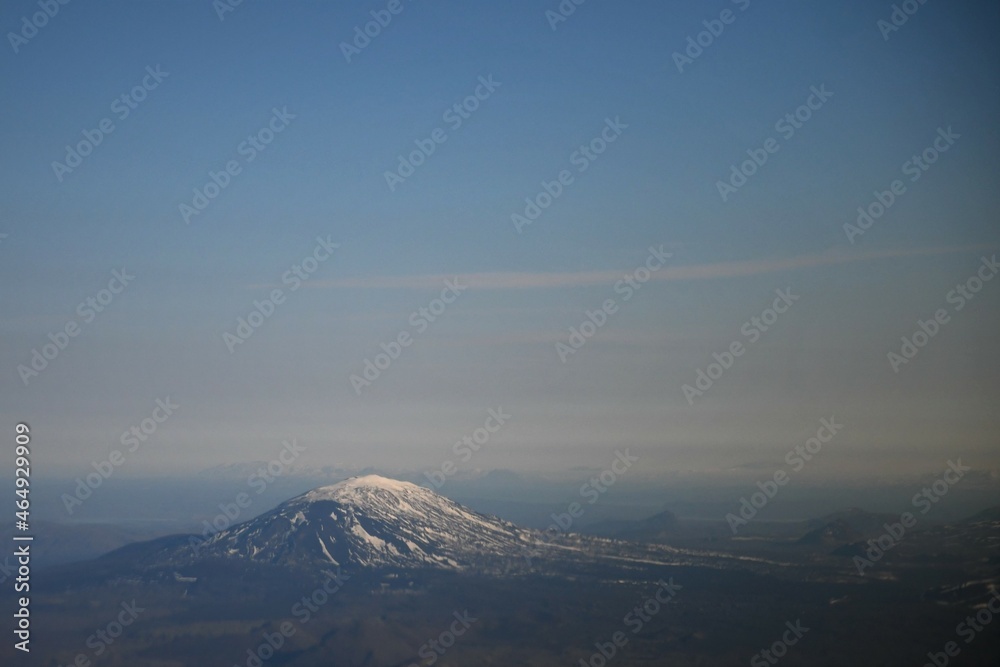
{"left": 0, "top": 523, "right": 1000, "bottom": 667}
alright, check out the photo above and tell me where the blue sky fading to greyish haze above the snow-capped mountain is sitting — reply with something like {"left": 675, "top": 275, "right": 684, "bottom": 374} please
{"left": 0, "top": 0, "right": 1000, "bottom": 477}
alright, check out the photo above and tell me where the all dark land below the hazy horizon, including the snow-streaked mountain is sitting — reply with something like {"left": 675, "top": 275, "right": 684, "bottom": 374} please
{"left": 0, "top": 475, "right": 1000, "bottom": 667}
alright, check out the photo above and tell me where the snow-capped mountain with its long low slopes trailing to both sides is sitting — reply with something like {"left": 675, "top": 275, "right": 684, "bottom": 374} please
{"left": 103, "top": 474, "right": 774, "bottom": 578}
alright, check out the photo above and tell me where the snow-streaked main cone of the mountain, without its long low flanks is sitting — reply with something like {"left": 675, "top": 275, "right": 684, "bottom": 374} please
{"left": 188, "top": 475, "right": 532, "bottom": 570}
